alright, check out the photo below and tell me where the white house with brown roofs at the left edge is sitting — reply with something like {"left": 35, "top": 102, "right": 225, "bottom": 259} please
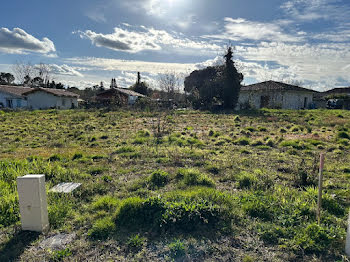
{"left": 0, "top": 85, "right": 79, "bottom": 109}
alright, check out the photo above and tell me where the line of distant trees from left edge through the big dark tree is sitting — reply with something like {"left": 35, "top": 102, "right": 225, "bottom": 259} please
{"left": 0, "top": 47, "right": 243, "bottom": 109}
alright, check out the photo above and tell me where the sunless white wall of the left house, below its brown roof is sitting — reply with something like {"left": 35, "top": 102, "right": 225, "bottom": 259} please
{"left": 27, "top": 91, "right": 78, "bottom": 109}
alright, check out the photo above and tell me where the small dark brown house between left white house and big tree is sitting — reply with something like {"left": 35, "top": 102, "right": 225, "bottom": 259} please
{"left": 95, "top": 87, "right": 146, "bottom": 105}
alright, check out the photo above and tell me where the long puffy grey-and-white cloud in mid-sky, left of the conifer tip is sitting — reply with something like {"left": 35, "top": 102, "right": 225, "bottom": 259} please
{"left": 77, "top": 26, "right": 221, "bottom": 55}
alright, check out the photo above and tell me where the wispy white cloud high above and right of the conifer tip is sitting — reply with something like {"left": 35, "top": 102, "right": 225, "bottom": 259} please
{"left": 204, "top": 17, "right": 303, "bottom": 42}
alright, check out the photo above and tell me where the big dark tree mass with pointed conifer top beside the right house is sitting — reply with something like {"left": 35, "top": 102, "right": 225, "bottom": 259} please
{"left": 185, "top": 47, "right": 243, "bottom": 109}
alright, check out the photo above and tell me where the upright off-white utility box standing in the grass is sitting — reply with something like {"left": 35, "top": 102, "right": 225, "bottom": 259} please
{"left": 17, "top": 175, "right": 49, "bottom": 232}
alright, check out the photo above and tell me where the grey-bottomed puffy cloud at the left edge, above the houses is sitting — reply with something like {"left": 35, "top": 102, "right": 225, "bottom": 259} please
{"left": 0, "top": 27, "right": 56, "bottom": 54}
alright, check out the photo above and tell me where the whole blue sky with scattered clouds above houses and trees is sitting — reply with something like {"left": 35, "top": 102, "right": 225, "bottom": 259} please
{"left": 0, "top": 0, "right": 350, "bottom": 90}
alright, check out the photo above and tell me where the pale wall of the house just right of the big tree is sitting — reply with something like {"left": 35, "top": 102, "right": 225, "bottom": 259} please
{"left": 236, "top": 91, "right": 313, "bottom": 110}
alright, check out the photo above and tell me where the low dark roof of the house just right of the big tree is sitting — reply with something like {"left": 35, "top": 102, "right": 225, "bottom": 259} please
{"left": 241, "top": 81, "right": 318, "bottom": 93}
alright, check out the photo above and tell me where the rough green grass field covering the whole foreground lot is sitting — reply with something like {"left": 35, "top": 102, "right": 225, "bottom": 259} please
{"left": 0, "top": 110, "right": 350, "bottom": 262}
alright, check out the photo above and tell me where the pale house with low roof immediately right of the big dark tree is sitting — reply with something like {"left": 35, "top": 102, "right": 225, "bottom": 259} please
{"left": 237, "top": 81, "right": 318, "bottom": 109}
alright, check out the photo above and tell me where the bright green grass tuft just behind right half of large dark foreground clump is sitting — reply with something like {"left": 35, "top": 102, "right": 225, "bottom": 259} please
{"left": 177, "top": 169, "right": 215, "bottom": 187}
